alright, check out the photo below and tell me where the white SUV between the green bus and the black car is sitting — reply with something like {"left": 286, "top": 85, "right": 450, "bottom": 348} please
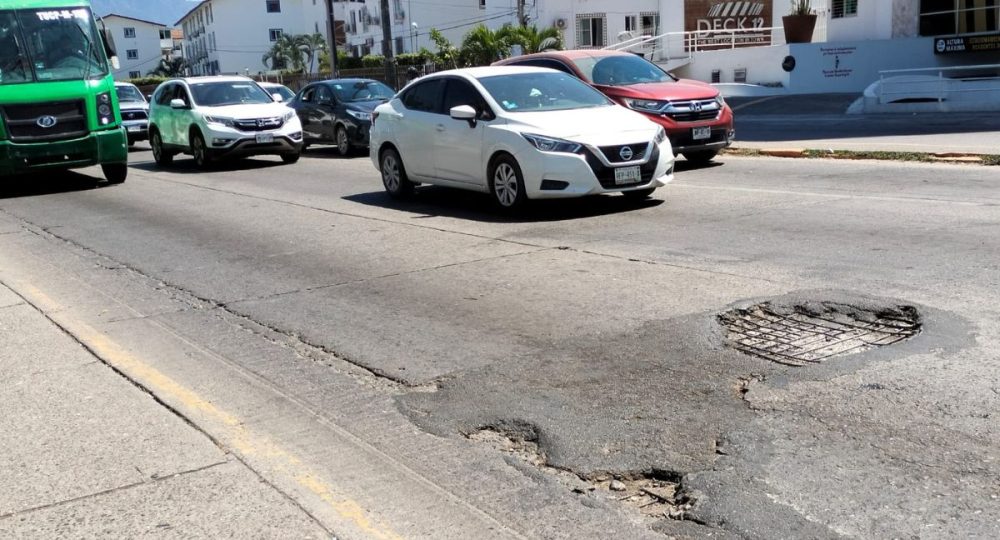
{"left": 149, "top": 77, "right": 302, "bottom": 168}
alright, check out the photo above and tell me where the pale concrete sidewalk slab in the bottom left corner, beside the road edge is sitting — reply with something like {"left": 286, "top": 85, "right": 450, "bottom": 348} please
{"left": 0, "top": 284, "right": 331, "bottom": 538}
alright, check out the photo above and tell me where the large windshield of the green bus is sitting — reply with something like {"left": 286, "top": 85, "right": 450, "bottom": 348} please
{"left": 0, "top": 8, "right": 108, "bottom": 84}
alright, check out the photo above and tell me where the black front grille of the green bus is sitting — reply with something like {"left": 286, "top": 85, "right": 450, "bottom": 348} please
{"left": 0, "top": 100, "right": 87, "bottom": 143}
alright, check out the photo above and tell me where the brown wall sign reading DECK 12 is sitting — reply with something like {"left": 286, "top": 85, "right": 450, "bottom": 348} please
{"left": 684, "top": 0, "right": 774, "bottom": 51}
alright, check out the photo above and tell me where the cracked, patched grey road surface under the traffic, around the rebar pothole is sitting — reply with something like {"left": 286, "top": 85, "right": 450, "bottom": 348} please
{"left": 0, "top": 144, "right": 1000, "bottom": 538}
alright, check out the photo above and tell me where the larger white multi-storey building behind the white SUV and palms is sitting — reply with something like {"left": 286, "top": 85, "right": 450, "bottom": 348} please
{"left": 177, "top": 0, "right": 328, "bottom": 75}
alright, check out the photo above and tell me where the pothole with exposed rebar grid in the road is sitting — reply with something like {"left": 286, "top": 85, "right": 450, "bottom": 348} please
{"left": 719, "top": 303, "right": 920, "bottom": 366}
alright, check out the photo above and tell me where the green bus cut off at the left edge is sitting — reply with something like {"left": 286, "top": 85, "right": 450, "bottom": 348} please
{"left": 0, "top": 0, "right": 128, "bottom": 184}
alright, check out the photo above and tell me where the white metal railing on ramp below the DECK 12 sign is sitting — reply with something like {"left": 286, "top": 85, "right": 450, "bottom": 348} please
{"left": 604, "top": 26, "right": 785, "bottom": 61}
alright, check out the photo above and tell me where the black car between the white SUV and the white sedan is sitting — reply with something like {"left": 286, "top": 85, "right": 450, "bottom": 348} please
{"left": 288, "top": 79, "right": 396, "bottom": 156}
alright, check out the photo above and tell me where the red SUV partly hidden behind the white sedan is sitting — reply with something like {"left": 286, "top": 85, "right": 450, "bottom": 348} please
{"left": 495, "top": 50, "right": 735, "bottom": 163}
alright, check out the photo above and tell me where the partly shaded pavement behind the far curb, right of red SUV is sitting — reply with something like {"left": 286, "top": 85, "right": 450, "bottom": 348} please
{"left": 728, "top": 94, "right": 1000, "bottom": 155}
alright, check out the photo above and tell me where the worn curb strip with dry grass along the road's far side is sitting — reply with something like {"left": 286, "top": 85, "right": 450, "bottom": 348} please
{"left": 722, "top": 147, "right": 1000, "bottom": 166}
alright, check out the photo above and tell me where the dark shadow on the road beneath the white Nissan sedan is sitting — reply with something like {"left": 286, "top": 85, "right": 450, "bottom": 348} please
{"left": 344, "top": 186, "right": 664, "bottom": 223}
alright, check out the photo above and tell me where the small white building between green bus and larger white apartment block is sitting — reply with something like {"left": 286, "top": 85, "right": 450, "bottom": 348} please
{"left": 102, "top": 13, "right": 174, "bottom": 80}
